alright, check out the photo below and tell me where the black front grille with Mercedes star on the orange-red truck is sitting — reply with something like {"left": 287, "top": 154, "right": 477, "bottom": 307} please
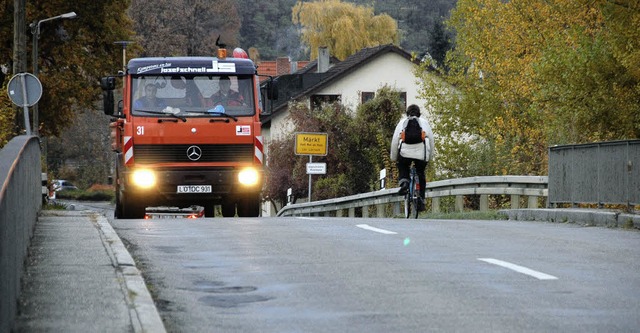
{"left": 133, "top": 145, "right": 254, "bottom": 163}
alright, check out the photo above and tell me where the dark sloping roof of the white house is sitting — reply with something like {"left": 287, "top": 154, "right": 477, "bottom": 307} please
{"left": 262, "top": 44, "right": 418, "bottom": 123}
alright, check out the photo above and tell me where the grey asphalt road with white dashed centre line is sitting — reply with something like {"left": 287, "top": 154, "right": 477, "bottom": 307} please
{"left": 94, "top": 202, "right": 640, "bottom": 332}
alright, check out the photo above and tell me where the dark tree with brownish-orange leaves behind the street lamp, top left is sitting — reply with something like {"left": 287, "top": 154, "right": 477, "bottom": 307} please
{"left": 0, "top": 0, "right": 137, "bottom": 138}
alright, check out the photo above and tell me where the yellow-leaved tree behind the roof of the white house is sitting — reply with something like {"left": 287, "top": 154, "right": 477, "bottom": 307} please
{"left": 292, "top": 0, "right": 399, "bottom": 60}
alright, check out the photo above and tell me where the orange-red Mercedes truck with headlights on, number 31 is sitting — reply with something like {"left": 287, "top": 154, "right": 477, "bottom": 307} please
{"left": 101, "top": 49, "right": 277, "bottom": 219}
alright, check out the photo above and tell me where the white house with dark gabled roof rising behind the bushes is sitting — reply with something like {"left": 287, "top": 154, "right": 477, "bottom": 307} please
{"left": 261, "top": 44, "right": 425, "bottom": 215}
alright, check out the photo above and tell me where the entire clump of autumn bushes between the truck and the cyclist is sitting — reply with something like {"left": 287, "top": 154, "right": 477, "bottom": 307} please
{"left": 263, "top": 87, "right": 403, "bottom": 209}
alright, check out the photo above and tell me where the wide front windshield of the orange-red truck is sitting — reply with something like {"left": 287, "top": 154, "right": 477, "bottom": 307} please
{"left": 131, "top": 75, "right": 255, "bottom": 117}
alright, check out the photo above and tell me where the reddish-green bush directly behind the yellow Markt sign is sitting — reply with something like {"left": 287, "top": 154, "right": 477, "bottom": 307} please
{"left": 264, "top": 103, "right": 370, "bottom": 203}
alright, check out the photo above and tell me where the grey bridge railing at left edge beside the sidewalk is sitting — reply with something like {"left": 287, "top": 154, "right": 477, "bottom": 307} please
{"left": 0, "top": 135, "right": 42, "bottom": 332}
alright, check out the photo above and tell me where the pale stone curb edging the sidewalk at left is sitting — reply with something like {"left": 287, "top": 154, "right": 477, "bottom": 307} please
{"left": 96, "top": 214, "right": 166, "bottom": 333}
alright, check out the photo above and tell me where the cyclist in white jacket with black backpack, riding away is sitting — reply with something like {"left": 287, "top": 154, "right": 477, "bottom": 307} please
{"left": 391, "top": 104, "right": 434, "bottom": 211}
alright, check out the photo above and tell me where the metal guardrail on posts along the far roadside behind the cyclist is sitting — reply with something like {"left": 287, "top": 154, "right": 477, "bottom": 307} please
{"left": 278, "top": 176, "right": 549, "bottom": 218}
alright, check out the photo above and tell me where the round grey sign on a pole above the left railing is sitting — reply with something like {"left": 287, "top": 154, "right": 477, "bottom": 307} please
{"left": 7, "top": 73, "right": 42, "bottom": 135}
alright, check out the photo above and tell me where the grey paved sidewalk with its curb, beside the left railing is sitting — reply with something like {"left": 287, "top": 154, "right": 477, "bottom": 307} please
{"left": 14, "top": 210, "right": 165, "bottom": 332}
